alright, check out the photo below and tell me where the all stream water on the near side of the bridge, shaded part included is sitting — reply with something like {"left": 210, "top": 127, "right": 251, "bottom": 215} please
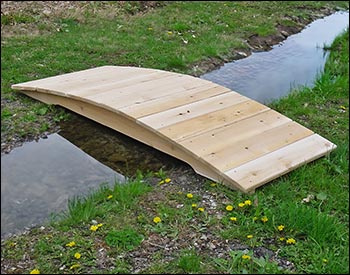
{"left": 1, "top": 115, "right": 185, "bottom": 237}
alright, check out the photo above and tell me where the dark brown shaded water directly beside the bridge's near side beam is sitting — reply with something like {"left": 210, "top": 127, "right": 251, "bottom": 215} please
{"left": 60, "top": 116, "right": 183, "bottom": 177}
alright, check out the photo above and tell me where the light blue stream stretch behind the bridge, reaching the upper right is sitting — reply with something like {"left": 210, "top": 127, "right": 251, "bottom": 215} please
{"left": 201, "top": 12, "right": 349, "bottom": 104}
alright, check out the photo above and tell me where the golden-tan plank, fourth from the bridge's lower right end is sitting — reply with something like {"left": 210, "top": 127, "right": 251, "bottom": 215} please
{"left": 159, "top": 100, "right": 270, "bottom": 143}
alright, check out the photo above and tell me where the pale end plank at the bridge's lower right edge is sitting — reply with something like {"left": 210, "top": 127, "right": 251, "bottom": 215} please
{"left": 225, "top": 134, "right": 336, "bottom": 192}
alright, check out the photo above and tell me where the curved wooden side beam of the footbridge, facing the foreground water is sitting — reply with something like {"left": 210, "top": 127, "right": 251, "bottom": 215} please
{"left": 21, "top": 89, "right": 241, "bottom": 192}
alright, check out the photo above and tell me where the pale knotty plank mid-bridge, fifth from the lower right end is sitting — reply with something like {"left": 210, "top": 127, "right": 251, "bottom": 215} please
{"left": 139, "top": 92, "right": 249, "bottom": 130}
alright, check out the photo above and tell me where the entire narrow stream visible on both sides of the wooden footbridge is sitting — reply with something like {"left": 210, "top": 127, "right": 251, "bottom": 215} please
{"left": 1, "top": 12, "right": 349, "bottom": 237}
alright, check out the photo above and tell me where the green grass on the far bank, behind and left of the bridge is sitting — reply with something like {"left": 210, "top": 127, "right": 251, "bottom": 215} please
{"left": 1, "top": 1, "right": 348, "bottom": 140}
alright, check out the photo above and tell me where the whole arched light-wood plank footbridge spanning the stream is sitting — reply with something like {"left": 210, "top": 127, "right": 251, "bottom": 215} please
{"left": 12, "top": 66, "right": 336, "bottom": 192}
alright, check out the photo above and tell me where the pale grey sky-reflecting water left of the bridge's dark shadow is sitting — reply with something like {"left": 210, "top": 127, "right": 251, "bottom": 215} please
{"left": 1, "top": 134, "right": 124, "bottom": 236}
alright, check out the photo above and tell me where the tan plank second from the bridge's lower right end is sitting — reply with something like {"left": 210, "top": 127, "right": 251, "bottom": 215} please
{"left": 201, "top": 121, "right": 313, "bottom": 171}
